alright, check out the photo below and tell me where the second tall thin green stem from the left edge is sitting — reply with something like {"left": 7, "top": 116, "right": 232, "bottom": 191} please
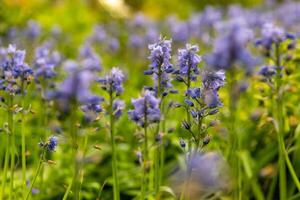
{"left": 20, "top": 81, "right": 26, "bottom": 198}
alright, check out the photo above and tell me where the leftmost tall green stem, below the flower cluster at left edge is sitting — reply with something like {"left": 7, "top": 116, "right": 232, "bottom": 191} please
{"left": 8, "top": 95, "right": 16, "bottom": 199}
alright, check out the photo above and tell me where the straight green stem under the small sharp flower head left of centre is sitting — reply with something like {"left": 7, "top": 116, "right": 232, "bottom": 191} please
{"left": 109, "top": 90, "right": 120, "bottom": 200}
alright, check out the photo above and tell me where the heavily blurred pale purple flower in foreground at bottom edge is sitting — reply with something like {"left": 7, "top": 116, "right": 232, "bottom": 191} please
{"left": 172, "top": 152, "right": 232, "bottom": 200}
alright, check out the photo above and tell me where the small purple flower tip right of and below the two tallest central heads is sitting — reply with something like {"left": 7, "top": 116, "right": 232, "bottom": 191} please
{"left": 202, "top": 70, "right": 225, "bottom": 90}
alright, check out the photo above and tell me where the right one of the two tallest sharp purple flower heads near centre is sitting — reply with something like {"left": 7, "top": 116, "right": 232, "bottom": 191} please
{"left": 177, "top": 44, "right": 201, "bottom": 80}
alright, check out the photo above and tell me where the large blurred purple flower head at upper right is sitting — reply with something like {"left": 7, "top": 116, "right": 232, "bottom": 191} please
{"left": 206, "top": 22, "right": 257, "bottom": 72}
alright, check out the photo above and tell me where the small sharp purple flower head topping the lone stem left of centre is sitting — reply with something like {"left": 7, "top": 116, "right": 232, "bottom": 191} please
{"left": 98, "top": 67, "right": 125, "bottom": 95}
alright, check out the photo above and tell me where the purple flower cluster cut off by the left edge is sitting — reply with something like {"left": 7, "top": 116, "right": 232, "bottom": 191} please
{"left": 0, "top": 45, "right": 33, "bottom": 95}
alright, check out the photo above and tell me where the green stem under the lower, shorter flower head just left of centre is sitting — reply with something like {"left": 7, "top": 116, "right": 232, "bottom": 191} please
{"left": 141, "top": 99, "right": 149, "bottom": 200}
